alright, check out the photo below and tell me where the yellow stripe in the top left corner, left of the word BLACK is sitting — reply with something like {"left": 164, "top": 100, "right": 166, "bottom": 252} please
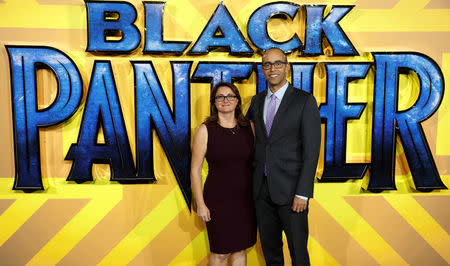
{"left": 0, "top": 0, "right": 86, "bottom": 29}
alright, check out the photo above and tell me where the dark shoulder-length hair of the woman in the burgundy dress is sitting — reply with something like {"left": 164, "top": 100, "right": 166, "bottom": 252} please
{"left": 205, "top": 82, "right": 249, "bottom": 127}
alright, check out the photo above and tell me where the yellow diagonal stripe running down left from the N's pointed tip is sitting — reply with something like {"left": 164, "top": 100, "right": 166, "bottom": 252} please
{"left": 99, "top": 187, "right": 187, "bottom": 265}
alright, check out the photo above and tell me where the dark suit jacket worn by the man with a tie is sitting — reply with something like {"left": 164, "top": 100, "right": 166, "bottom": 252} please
{"left": 249, "top": 84, "right": 321, "bottom": 205}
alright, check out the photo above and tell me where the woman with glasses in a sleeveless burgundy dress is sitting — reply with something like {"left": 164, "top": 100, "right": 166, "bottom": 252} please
{"left": 191, "top": 82, "right": 256, "bottom": 265}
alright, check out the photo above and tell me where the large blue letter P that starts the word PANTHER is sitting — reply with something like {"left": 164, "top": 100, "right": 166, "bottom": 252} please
{"left": 6, "top": 46, "right": 82, "bottom": 190}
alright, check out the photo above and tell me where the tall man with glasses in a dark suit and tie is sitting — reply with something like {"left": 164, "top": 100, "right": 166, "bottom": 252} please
{"left": 250, "top": 48, "right": 321, "bottom": 265}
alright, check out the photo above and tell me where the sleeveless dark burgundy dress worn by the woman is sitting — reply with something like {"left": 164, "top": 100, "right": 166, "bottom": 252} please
{"left": 204, "top": 124, "right": 256, "bottom": 254}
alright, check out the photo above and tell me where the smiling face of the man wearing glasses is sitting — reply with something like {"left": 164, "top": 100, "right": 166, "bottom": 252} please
{"left": 262, "top": 49, "right": 289, "bottom": 91}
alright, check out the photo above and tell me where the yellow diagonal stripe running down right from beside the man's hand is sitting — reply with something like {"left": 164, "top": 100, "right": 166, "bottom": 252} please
{"left": 315, "top": 183, "right": 408, "bottom": 265}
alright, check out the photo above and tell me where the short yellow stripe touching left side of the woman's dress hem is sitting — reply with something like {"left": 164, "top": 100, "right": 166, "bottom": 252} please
{"left": 169, "top": 229, "right": 209, "bottom": 266}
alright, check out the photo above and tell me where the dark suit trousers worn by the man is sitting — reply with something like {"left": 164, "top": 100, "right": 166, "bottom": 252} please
{"left": 255, "top": 177, "right": 310, "bottom": 266}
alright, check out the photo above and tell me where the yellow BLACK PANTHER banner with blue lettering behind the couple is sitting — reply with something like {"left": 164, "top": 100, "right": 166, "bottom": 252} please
{"left": 0, "top": 0, "right": 450, "bottom": 265}
